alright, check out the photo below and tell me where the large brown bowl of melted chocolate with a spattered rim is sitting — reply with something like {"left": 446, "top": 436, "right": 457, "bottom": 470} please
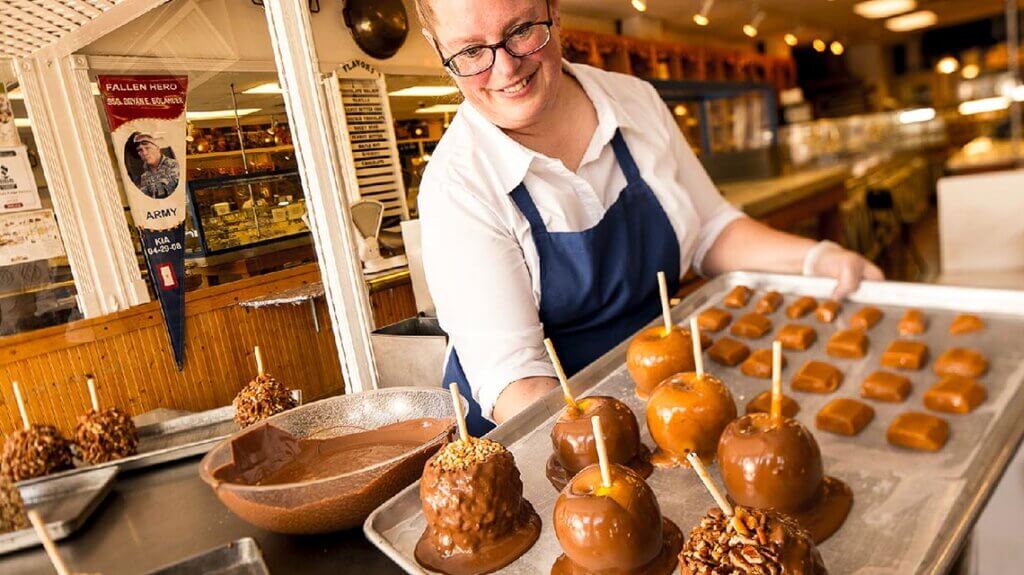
{"left": 200, "top": 388, "right": 455, "bottom": 534}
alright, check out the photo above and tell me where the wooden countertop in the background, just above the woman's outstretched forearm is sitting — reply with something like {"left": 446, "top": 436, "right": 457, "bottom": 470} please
{"left": 718, "top": 165, "right": 850, "bottom": 218}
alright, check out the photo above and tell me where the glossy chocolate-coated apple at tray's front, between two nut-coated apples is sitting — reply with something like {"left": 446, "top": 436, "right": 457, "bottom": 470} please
{"left": 551, "top": 462, "right": 683, "bottom": 575}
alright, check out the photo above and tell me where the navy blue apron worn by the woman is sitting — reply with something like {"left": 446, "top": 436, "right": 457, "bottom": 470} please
{"left": 443, "top": 130, "right": 680, "bottom": 437}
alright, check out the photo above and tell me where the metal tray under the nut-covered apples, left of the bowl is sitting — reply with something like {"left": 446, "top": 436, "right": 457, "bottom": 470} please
{"left": 18, "top": 390, "right": 302, "bottom": 486}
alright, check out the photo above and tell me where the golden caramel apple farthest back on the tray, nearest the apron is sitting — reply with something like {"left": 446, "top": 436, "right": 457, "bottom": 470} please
{"left": 626, "top": 325, "right": 693, "bottom": 399}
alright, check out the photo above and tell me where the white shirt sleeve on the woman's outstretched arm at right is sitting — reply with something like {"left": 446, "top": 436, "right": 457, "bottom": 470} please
{"left": 651, "top": 89, "right": 745, "bottom": 274}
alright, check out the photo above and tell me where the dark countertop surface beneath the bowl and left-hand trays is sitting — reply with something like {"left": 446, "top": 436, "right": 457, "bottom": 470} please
{"left": 0, "top": 458, "right": 401, "bottom": 575}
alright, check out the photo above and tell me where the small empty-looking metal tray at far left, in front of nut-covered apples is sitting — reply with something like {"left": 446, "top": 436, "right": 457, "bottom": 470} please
{"left": 0, "top": 468, "right": 118, "bottom": 555}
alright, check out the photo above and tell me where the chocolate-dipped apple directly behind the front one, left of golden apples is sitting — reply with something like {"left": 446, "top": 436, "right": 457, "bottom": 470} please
{"left": 547, "top": 396, "right": 653, "bottom": 491}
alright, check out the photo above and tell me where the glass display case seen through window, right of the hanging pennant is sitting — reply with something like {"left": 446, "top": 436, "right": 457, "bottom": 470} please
{"left": 185, "top": 171, "right": 309, "bottom": 258}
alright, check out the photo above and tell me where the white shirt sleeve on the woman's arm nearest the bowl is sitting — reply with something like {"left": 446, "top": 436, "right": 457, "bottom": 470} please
{"left": 420, "top": 173, "right": 555, "bottom": 418}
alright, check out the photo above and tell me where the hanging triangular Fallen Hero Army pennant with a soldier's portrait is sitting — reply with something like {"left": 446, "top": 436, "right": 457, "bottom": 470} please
{"left": 97, "top": 76, "right": 188, "bottom": 369}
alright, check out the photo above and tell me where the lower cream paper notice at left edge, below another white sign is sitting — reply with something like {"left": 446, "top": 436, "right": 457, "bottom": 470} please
{"left": 0, "top": 210, "right": 65, "bottom": 267}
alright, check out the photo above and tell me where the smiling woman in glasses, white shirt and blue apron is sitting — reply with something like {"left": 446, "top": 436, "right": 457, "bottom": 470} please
{"left": 417, "top": 0, "right": 882, "bottom": 433}
